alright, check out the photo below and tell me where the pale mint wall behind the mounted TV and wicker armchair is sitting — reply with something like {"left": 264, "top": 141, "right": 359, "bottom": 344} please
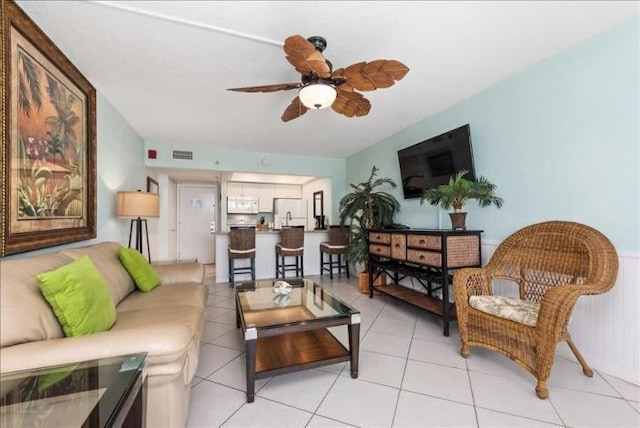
{"left": 347, "top": 16, "right": 640, "bottom": 251}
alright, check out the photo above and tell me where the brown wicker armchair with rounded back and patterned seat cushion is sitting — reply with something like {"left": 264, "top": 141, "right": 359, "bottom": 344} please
{"left": 453, "top": 221, "right": 618, "bottom": 399}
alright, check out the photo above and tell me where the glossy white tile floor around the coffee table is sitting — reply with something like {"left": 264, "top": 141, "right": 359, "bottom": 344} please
{"left": 188, "top": 275, "right": 640, "bottom": 428}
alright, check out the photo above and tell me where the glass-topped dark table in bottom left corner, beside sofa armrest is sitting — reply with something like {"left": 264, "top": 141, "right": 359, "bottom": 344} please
{"left": 0, "top": 353, "right": 146, "bottom": 428}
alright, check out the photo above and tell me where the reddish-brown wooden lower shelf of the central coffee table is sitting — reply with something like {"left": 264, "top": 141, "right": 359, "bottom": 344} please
{"left": 256, "top": 329, "right": 351, "bottom": 379}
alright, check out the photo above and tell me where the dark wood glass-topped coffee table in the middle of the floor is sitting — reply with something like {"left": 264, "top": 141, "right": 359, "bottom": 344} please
{"left": 236, "top": 278, "right": 360, "bottom": 403}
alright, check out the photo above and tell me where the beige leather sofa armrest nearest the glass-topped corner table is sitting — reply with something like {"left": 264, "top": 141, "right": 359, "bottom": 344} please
{"left": 0, "top": 324, "right": 193, "bottom": 373}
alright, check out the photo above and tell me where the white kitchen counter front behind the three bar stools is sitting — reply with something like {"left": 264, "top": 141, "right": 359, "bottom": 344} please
{"left": 216, "top": 229, "right": 329, "bottom": 283}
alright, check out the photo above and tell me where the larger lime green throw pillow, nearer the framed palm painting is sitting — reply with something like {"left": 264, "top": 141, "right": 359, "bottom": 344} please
{"left": 36, "top": 255, "right": 116, "bottom": 336}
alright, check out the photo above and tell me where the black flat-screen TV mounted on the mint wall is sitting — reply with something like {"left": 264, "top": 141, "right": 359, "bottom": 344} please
{"left": 398, "top": 124, "right": 476, "bottom": 199}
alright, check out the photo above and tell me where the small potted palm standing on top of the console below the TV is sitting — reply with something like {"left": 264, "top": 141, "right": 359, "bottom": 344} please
{"left": 420, "top": 169, "right": 504, "bottom": 230}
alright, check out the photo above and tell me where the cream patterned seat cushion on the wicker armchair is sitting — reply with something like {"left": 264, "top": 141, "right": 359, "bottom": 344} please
{"left": 469, "top": 296, "right": 540, "bottom": 327}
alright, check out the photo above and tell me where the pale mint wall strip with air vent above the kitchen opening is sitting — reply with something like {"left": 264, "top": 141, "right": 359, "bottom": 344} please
{"left": 146, "top": 141, "right": 346, "bottom": 224}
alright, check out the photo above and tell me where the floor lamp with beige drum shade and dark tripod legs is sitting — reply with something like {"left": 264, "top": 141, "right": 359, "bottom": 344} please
{"left": 116, "top": 190, "right": 160, "bottom": 263}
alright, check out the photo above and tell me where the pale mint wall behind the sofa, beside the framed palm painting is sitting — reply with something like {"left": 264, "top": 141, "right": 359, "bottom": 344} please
{"left": 6, "top": 93, "right": 147, "bottom": 259}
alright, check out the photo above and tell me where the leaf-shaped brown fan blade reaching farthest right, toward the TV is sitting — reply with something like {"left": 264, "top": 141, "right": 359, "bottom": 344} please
{"left": 340, "top": 59, "right": 409, "bottom": 91}
